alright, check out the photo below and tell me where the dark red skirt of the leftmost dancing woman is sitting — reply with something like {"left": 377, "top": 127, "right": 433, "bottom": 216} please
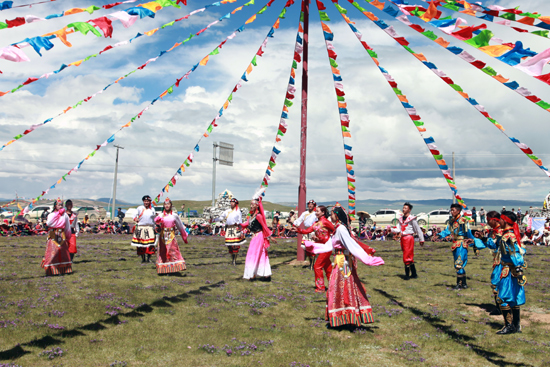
{"left": 40, "top": 228, "right": 73, "bottom": 275}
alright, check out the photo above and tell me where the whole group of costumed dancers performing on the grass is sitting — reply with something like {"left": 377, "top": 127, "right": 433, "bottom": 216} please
{"left": 37, "top": 194, "right": 526, "bottom": 334}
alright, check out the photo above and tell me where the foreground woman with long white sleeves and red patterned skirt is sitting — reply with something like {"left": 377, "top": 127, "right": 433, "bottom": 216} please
{"left": 325, "top": 206, "right": 384, "bottom": 327}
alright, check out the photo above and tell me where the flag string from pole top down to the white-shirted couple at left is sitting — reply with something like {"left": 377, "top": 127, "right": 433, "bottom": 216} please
{"left": 153, "top": 0, "right": 294, "bottom": 204}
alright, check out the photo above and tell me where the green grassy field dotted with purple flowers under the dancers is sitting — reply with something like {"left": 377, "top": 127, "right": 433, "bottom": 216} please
{"left": 0, "top": 235, "right": 550, "bottom": 366}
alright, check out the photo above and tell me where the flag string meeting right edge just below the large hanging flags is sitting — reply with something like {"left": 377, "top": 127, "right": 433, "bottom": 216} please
{"left": 366, "top": 0, "right": 550, "bottom": 112}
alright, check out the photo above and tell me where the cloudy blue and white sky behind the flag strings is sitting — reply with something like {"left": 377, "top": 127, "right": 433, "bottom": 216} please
{"left": 0, "top": 0, "right": 550, "bottom": 204}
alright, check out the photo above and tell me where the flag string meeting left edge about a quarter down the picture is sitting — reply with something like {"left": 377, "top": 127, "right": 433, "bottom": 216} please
{"left": 0, "top": 0, "right": 239, "bottom": 97}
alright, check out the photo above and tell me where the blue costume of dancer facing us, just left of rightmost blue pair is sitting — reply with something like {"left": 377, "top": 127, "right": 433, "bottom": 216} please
{"left": 439, "top": 215, "right": 484, "bottom": 290}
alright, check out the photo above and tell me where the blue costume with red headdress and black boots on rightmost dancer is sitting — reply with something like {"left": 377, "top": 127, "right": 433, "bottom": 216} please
{"left": 496, "top": 214, "right": 527, "bottom": 334}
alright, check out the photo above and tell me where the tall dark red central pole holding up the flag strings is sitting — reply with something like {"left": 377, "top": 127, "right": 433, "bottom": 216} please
{"left": 297, "top": 0, "right": 309, "bottom": 261}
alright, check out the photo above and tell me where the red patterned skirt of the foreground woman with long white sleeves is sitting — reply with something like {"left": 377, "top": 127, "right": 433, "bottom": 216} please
{"left": 325, "top": 253, "right": 374, "bottom": 327}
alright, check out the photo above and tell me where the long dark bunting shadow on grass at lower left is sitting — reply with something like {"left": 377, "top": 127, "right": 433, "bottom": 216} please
{"left": 0, "top": 280, "right": 225, "bottom": 361}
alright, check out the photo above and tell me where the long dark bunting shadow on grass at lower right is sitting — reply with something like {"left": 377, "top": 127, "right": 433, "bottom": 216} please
{"left": 374, "top": 288, "right": 532, "bottom": 367}
